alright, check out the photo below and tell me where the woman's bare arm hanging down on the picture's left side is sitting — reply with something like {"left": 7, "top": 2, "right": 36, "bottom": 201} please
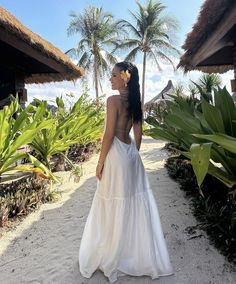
{"left": 96, "top": 96, "right": 117, "bottom": 180}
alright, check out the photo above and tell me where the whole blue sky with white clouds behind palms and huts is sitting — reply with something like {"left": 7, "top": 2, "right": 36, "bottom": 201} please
{"left": 0, "top": 0, "right": 232, "bottom": 101}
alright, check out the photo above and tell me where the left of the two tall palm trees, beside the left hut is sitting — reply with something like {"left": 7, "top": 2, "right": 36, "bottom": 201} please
{"left": 66, "top": 6, "right": 118, "bottom": 99}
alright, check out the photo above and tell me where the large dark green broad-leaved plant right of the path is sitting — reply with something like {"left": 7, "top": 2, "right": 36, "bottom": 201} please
{"left": 146, "top": 85, "right": 236, "bottom": 188}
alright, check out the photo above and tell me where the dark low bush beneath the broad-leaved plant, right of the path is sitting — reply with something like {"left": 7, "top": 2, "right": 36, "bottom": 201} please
{"left": 165, "top": 156, "right": 236, "bottom": 264}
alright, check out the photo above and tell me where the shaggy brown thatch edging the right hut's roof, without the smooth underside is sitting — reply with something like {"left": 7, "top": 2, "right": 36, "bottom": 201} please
{"left": 178, "top": 0, "right": 236, "bottom": 73}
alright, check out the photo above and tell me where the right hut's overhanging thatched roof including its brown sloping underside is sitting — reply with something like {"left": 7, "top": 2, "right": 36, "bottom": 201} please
{"left": 178, "top": 0, "right": 236, "bottom": 92}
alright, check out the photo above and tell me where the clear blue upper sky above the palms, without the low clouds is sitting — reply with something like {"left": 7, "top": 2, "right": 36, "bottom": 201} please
{"left": 0, "top": 0, "right": 202, "bottom": 51}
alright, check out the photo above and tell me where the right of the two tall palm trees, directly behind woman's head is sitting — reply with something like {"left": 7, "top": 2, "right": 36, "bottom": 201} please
{"left": 118, "top": 0, "right": 179, "bottom": 108}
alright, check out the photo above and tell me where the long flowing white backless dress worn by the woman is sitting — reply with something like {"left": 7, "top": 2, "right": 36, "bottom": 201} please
{"left": 79, "top": 136, "right": 174, "bottom": 283}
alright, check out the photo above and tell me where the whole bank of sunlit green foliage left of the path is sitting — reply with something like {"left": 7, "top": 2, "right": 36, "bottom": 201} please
{"left": 0, "top": 94, "right": 104, "bottom": 226}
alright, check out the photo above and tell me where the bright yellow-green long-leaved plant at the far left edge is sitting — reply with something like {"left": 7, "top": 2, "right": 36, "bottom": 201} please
{"left": 0, "top": 97, "right": 53, "bottom": 178}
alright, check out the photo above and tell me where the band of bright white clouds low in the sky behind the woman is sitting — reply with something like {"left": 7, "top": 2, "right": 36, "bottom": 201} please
{"left": 26, "top": 60, "right": 233, "bottom": 105}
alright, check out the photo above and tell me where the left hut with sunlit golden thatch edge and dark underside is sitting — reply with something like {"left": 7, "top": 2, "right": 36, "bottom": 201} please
{"left": 0, "top": 7, "right": 83, "bottom": 104}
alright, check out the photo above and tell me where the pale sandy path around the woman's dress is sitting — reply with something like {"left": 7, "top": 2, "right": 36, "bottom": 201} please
{"left": 0, "top": 138, "right": 236, "bottom": 284}
